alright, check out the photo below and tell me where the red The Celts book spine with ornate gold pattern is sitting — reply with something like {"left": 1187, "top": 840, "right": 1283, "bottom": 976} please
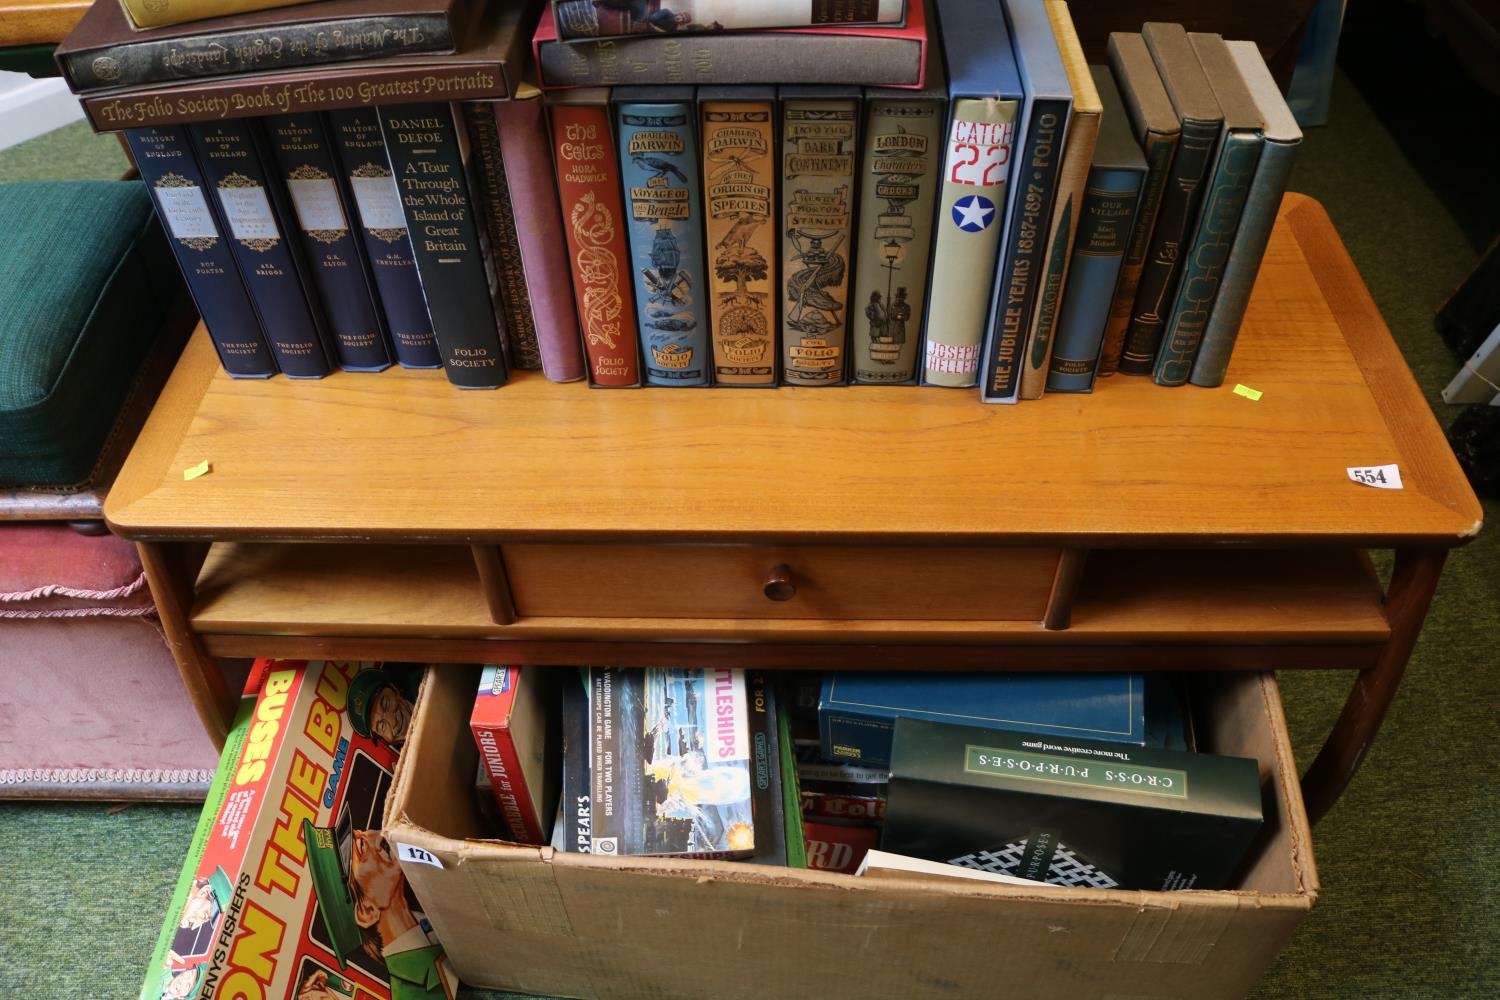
{"left": 551, "top": 102, "right": 641, "bottom": 387}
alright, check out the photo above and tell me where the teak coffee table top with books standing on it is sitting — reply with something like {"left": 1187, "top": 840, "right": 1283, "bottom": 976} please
{"left": 105, "top": 195, "right": 1482, "bottom": 547}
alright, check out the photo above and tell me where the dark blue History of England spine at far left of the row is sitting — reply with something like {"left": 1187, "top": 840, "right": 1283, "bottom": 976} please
{"left": 125, "top": 126, "right": 276, "bottom": 378}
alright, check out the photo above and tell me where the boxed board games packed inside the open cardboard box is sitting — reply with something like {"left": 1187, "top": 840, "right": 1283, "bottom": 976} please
{"left": 471, "top": 666, "right": 1262, "bottom": 891}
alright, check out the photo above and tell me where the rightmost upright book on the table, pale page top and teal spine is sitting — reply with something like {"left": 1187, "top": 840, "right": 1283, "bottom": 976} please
{"left": 1191, "top": 42, "right": 1302, "bottom": 387}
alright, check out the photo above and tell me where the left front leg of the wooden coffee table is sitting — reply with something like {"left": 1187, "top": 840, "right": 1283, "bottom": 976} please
{"left": 135, "top": 541, "right": 234, "bottom": 750}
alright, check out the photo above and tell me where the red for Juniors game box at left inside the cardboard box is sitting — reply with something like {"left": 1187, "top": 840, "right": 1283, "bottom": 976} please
{"left": 470, "top": 664, "right": 561, "bottom": 844}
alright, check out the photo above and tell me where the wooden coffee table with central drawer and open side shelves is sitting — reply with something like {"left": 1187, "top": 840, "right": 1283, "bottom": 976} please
{"left": 105, "top": 195, "right": 1482, "bottom": 817}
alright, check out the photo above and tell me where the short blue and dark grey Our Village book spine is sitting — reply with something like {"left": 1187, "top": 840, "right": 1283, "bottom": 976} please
{"left": 1047, "top": 167, "right": 1143, "bottom": 393}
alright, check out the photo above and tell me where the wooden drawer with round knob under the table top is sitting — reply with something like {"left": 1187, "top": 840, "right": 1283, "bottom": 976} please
{"left": 500, "top": 543, "right": 1061, "bottom": 621}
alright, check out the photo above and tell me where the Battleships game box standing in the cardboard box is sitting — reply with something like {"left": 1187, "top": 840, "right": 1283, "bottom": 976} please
{"left": 590, "top": 667, "right": 756, "bottom": 858}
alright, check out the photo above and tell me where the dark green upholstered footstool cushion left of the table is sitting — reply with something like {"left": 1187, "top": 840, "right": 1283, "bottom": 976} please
{"left": 0, "top": 181, "right": 182, "bottom": 489}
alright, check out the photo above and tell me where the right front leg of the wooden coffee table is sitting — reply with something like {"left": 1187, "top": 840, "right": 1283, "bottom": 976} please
{"left": 1302, "top": 549, "right": 1448, "bottom": 823}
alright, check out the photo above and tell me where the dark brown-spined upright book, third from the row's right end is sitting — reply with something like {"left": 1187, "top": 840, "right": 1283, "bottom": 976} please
{"left": 1119, "top": 21, "right": 1224, "bottom": 375}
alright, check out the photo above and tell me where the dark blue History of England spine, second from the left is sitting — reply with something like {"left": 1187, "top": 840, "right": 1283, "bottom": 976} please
{"left": 188, "top": 118, "right": 333, "bottom": 378}
